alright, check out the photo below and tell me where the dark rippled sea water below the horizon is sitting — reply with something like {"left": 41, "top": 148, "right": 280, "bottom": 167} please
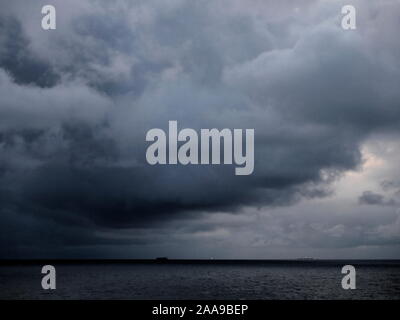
{"left": 0, "top": 261, "right": 400, "bottom": 299}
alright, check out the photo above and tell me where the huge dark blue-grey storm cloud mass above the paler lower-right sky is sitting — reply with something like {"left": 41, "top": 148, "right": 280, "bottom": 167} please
{"left": 0, "top": 1, "right": 400, "bottom": 256}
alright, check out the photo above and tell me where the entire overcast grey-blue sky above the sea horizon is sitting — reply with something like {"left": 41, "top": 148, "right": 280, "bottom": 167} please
{"left": 0, "top": 0, "right": 400, "bottom": 258}
